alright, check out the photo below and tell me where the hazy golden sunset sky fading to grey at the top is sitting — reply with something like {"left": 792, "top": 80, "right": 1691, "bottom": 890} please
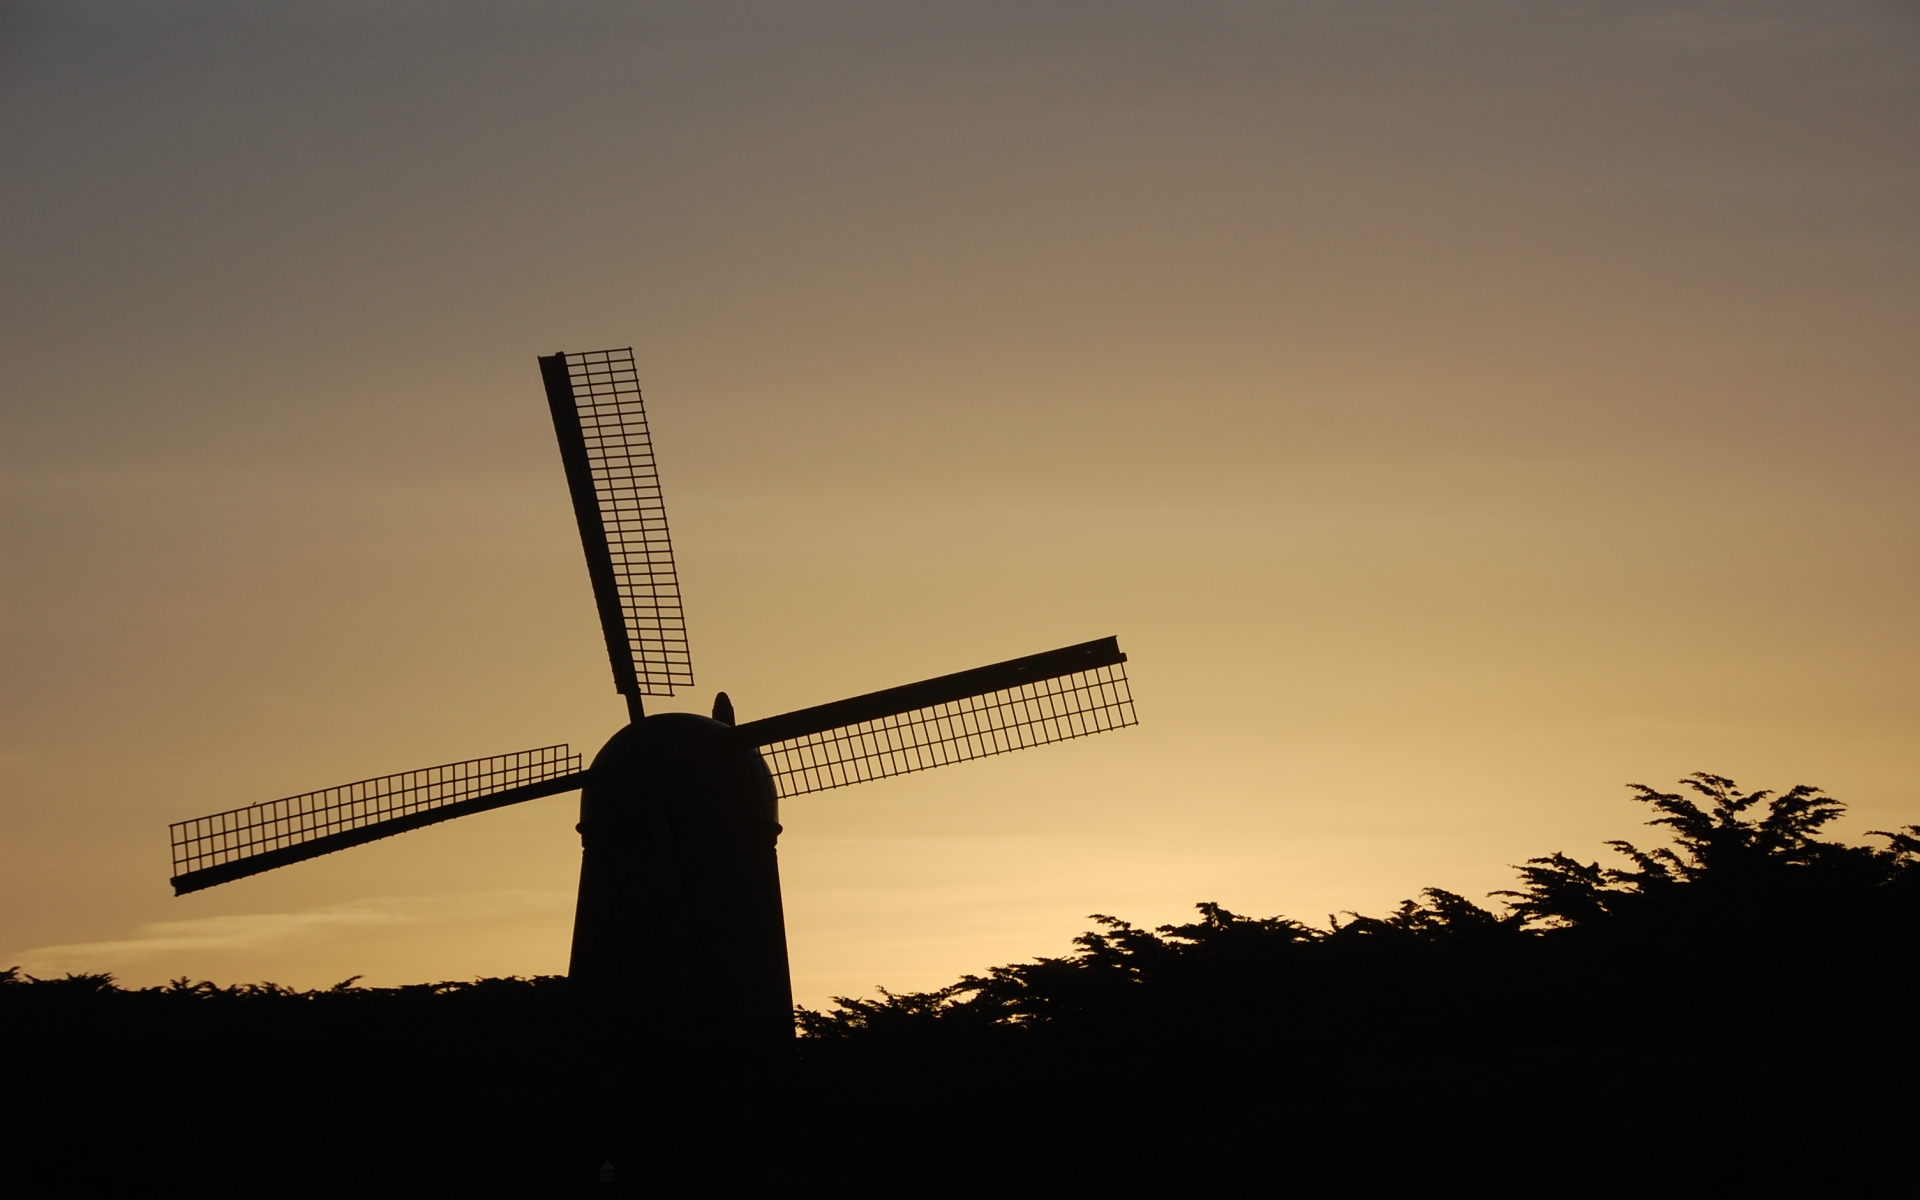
{"left": 0, "top": 0, "right": 1920, "bottom": 1006}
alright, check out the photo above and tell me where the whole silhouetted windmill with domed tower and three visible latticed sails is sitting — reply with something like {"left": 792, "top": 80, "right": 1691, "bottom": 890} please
{"left": 171, "top": 349, "right": 1135, "bottom": 1046}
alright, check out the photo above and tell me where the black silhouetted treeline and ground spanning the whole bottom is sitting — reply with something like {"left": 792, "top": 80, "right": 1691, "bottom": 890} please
{"left": 0, "top": 774, "right": 1920, "bottom": 1194}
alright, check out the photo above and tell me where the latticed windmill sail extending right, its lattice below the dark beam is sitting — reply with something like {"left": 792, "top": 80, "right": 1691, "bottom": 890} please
{"left": 737, "top": 637, "right": 1139, "bottom": 797}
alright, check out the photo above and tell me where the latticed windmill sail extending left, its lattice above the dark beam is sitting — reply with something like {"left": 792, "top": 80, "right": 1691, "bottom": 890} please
{"left": 169, "top": 745, "right": 586, "bottom": 895}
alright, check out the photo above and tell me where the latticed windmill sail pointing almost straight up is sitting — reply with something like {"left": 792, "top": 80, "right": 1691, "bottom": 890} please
{"left": 540, "top": 349, "right": 693, "bottom": 720}
